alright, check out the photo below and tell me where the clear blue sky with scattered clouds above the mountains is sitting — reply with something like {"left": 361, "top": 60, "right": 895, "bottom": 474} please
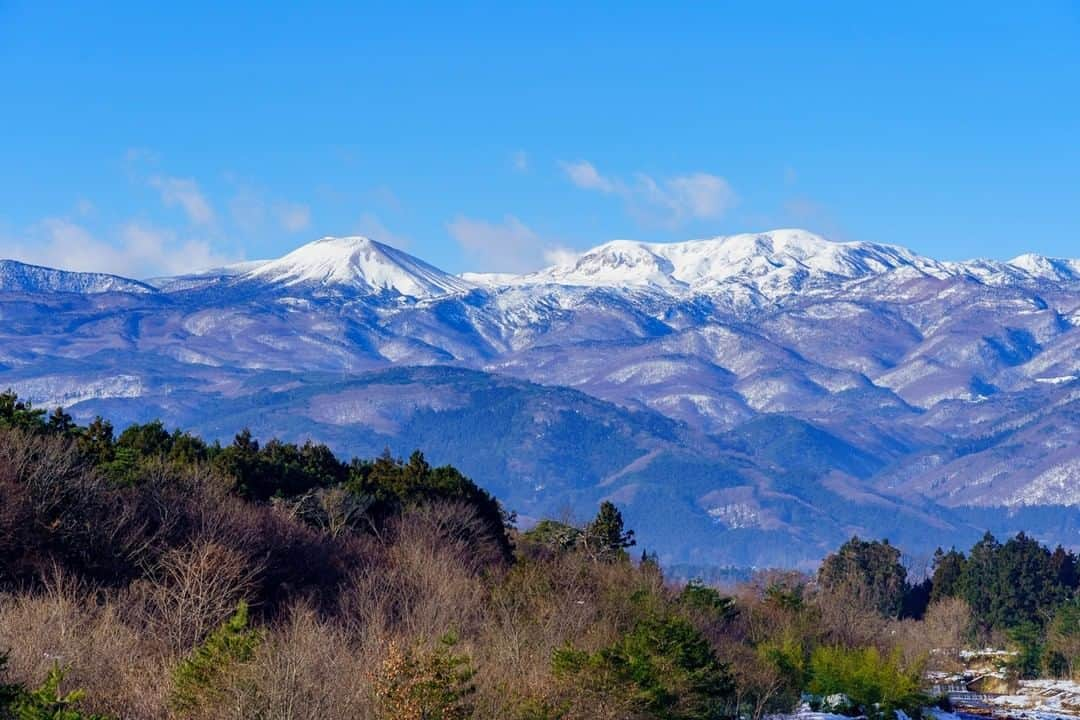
{"left": 0, "top": 0, "right": 1080, "bottom": 275}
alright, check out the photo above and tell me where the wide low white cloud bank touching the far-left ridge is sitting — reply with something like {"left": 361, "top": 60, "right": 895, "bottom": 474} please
{"left": 4, "top": 218, "right": 237, "bottom": 279}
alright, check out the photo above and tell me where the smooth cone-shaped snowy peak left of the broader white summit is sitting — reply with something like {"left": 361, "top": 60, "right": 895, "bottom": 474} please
{"left": 241, "top": 236, "right": 472, "bottom": 298}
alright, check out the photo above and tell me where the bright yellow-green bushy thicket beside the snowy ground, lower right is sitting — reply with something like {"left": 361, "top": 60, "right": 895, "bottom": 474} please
{"left": 809, "top": 647, "right": 928, "bottom": 720}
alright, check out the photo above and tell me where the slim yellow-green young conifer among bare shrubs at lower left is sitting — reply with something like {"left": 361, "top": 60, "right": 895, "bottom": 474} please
{"left": 170, "top": 601, "right": 262, "bottom": 714}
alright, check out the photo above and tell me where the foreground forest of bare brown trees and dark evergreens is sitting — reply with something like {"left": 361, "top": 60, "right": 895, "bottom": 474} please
{"left": 0, "top": 393, "right": 1080, "bottom": 720}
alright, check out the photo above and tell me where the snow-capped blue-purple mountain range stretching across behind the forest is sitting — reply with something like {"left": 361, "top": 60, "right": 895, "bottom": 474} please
{"left": 0, "top": 230, "right": 1080, "bottom": 568}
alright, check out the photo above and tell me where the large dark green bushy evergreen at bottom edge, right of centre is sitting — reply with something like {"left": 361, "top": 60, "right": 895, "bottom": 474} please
{"left": 552, "top": 615, "right": 734, "bottom": 720}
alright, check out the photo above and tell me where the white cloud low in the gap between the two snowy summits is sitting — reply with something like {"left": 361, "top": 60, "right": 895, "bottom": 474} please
{"left": 446, "top": 215, "right": 570, "bottom": 272}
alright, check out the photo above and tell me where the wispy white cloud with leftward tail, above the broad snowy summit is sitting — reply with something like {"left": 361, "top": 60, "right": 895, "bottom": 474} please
{"left": 563, "top": 160, "right": 739, "bottom": 227}
